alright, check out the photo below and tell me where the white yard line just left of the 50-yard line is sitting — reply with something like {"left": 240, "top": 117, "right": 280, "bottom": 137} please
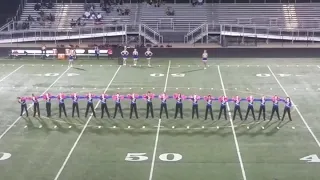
{"left": 54, "top": 66, "right": 122, "bottom": 180}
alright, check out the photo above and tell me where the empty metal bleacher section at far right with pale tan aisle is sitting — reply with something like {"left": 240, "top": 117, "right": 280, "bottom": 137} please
{"left": 212, "top": 3, "right": 320, "bottom": 29}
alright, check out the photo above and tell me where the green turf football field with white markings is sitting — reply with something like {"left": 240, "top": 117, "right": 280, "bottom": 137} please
{"left": 0, "top": 59, "right": 320, "bottom": 180}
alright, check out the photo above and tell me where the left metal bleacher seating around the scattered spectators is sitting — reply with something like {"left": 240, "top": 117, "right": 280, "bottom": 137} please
{"left": 21, "top": 3, "right": 137, "bottom": 30}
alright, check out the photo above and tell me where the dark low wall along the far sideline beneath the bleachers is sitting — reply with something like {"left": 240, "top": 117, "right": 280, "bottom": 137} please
{"left": 0, "top": 47, "right": 320, "bottom": 58}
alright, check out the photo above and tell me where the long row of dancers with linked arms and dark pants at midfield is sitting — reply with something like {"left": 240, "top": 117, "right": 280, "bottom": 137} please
{"left": 18, "top": 92, "right": 292, "bottom": 121}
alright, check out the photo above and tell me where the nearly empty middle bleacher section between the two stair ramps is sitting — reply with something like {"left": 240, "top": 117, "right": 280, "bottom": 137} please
{"left": 140, "top": 3, "right": 211, "bottom": 32}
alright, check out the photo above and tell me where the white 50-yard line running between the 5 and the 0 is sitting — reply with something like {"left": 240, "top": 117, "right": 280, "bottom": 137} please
{"left": 149, "top": 60, "right": 171, "bottom": 180}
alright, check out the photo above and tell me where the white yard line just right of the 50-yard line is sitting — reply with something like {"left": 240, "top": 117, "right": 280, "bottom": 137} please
{"left": 217, "top": 65, "right": 247, "bottom": 180}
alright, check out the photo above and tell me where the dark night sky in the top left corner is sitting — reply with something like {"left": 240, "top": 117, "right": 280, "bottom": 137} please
{"left": 0, "top": 0, "right": 21, "bottom": 23}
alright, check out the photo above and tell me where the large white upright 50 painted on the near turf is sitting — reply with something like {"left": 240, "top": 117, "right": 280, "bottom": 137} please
{"left": 125, "top": 153, "right": 182, "bottom": 162}
